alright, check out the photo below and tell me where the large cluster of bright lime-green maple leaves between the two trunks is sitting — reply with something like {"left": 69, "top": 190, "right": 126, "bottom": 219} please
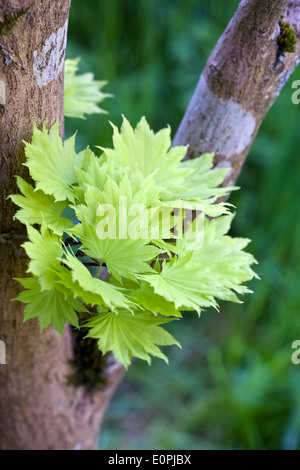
{"left": 10, "top": 59, "right": 257, "bottom": 368}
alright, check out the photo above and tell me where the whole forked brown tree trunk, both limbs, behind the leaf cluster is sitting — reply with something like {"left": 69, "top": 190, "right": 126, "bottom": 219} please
{"left": 0, "top": 0, "right": 300, "bottom": 449}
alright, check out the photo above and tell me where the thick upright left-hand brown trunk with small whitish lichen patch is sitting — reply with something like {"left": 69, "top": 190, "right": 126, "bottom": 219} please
{"left": 0, "top": 0, "right": 123, "bottom": 450}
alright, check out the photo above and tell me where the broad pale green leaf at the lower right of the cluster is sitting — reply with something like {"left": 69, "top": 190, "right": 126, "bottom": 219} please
{"left": 140, "top": 215, "right": 257, "bottom": 312}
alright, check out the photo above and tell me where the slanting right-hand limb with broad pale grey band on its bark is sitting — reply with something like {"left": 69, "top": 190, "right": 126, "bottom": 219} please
{"left": 173, "top": 0, "right": 300, "bottom": 185}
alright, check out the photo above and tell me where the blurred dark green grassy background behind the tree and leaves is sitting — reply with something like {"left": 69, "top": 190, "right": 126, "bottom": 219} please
{"left": 66, "top": 0, "right": 300, "bottom": 450}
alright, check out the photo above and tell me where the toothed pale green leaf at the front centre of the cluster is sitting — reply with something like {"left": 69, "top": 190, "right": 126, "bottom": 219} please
{"left": 72, "top": 175, "right": 163, "bottom": 280}
